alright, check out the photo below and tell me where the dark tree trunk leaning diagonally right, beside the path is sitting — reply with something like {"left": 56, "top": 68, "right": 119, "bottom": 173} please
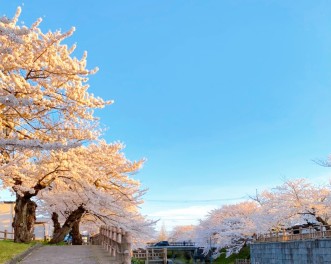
{"left": 49, "top": 206, "right": 86, "bottom": 244}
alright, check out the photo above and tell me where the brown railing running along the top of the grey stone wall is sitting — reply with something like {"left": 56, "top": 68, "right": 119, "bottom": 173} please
{"left": 253, "top": 225, "right": 331, "bottom": 243}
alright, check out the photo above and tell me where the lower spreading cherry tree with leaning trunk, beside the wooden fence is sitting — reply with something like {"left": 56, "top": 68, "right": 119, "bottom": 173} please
{"left": 34, "top": 141, "right": 152, "bottom": 243}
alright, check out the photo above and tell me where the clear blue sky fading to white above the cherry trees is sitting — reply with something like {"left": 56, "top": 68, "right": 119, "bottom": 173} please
{"left": 0, "top": 0, "right": 331, "bottom": 231}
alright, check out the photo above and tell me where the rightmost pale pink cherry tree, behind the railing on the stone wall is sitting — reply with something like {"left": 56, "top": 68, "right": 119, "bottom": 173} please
{"left": 254, "top": 178, "right": 331, "bottom": 228}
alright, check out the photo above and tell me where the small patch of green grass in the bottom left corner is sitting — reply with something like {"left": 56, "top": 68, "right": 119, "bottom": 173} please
{"left": 0, "top": 240, "right": 36, "bottom": 263}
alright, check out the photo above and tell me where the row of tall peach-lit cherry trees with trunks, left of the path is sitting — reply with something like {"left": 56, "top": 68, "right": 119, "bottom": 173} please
{"left": 0, "top": 8, "right": 151, "bottom": 243}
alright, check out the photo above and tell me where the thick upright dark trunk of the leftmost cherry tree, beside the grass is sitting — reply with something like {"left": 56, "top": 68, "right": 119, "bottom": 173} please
{"left": 13, "top": 194, "right": 37, "bottom": 243}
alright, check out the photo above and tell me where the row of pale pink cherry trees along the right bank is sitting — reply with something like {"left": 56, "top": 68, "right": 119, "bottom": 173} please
{"left": 170, "top": 179, "right": 331, "bottom": 256}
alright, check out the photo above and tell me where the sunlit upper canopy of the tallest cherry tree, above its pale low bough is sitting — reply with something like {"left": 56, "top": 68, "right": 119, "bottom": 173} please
{"left": 0, "top": 8, "right": 111, "bottom": 153}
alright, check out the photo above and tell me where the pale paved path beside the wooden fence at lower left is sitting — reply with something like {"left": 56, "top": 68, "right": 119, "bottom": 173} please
{"left": 19, "top": 246, "right": 115, "bottom": 264}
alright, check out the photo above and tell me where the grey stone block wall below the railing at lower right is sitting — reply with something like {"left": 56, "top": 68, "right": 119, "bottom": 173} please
{"left": 250, "top": 239, "right": 331, "bottom": 264}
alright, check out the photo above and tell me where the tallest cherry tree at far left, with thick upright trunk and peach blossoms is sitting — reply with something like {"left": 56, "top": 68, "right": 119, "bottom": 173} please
{"left": 0, "top": 8, "right": 111, "bottom": 242}
